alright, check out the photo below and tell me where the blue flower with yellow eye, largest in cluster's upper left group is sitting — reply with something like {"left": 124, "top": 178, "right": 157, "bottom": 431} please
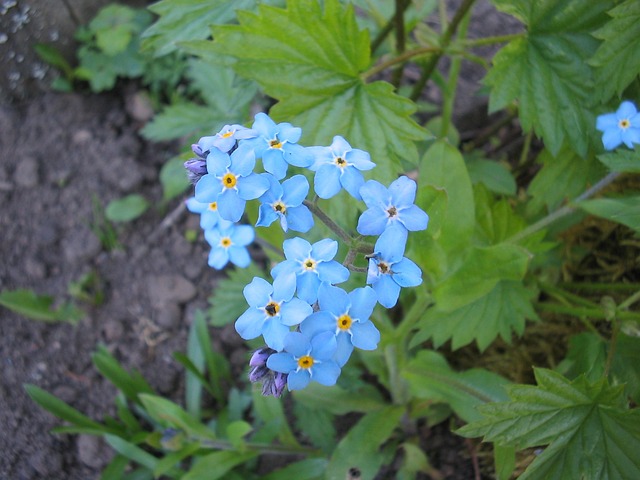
{"left": 195, "top": 146, "right": 269, "bottom": 222}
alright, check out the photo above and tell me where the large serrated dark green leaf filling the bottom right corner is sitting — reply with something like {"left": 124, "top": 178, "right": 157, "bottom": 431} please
{"left": 457, "top": 369, "right": 640, "bottom": 480}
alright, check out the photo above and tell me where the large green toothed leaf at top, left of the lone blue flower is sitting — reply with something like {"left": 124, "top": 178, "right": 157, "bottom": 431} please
{"left": 485, "top": 0, "right": 613, "bottom": 156}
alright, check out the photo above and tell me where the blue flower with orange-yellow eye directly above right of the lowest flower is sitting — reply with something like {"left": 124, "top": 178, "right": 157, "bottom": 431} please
{"left": 300, "top": 283, "right": 380, "bottom": 367}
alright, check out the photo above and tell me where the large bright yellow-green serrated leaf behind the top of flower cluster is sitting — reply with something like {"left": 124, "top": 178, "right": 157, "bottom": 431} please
{"left": 213, "top": 0, "right": 427, "bottom": 182}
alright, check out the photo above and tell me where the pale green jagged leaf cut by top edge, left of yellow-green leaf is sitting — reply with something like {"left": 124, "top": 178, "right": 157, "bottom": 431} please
{"left": 142, "top": 0, "right": 255, "bottom": 57}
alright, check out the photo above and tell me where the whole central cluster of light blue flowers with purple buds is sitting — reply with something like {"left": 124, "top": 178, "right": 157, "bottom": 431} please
{"left": 185, "top": 113, "right": 429, "bottom": 396}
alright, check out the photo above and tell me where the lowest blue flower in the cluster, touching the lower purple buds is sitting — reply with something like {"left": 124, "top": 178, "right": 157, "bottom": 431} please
{"left": 267, "top": 332, "right": 340, "bottom": 390}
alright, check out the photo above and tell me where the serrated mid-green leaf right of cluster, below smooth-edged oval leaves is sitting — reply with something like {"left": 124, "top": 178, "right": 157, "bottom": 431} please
{"left": 410, "top": 280, "right": 538, "bottom": 351}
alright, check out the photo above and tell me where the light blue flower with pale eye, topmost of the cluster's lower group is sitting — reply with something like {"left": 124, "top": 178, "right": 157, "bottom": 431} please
{"left": 271, "top": 237, "right": 349, "bottom": 304}
